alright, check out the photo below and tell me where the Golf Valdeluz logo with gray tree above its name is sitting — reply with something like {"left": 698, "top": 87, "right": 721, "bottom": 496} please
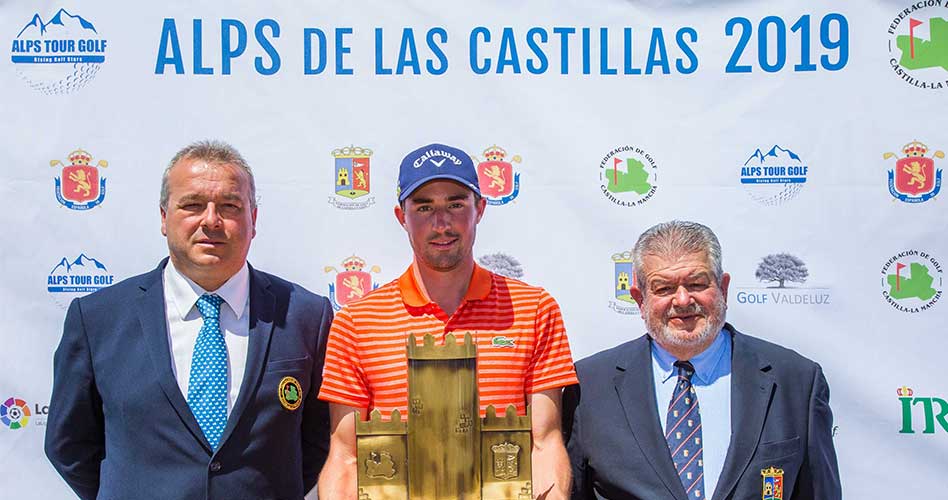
{"left": 735, "top": 253, "right": 832, "bottom": 306}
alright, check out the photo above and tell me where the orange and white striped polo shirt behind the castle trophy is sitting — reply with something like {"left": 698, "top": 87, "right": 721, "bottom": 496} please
{"left": 319, "top": 264, "right": 577, "bottom": 418}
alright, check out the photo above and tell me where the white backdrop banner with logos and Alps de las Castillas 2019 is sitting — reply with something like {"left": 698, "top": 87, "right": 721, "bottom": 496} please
{"left": 0, "top": 0, "right": 948, "bottom": 499}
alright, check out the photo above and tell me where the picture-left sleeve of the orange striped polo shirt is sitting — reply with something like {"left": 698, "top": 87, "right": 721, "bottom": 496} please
{"left": 319, "top": 308, "right": 371, "bottom": 408}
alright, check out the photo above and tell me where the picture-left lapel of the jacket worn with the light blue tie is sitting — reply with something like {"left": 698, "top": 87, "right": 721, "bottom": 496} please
{"left": 137, "top": 258, "right": 211, "bottom": 452}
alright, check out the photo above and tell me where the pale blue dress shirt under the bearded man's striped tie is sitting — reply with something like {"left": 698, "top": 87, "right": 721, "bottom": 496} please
{"left": 652, "top": 330, "right": 731, "bottom": 498}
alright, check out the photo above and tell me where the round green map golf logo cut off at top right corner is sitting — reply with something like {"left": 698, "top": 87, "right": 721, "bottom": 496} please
{"left": 888, "top": 0, "right": 948, "bottom": 90}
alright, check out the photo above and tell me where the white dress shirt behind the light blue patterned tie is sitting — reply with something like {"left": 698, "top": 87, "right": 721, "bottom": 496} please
{"left": 162, "top": 260, "right": 250, "bottom": 416}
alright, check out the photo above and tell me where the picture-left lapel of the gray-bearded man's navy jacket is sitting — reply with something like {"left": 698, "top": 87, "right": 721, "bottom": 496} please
{"left": 614, "top": 336, "right": 687, "bottom": 499}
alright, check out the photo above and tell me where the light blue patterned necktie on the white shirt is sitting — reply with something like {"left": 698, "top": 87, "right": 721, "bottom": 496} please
{"left": 188, "top": 294, "right": 227, "bottom": 450}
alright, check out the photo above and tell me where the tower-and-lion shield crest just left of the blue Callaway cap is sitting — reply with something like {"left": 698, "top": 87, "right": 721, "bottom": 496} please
{"left": 329, "top": 146, "right": 375, "bottom": 210}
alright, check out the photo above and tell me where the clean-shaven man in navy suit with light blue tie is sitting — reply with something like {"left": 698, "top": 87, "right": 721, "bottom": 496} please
{"left": 46, "top": 142, "right": 332, "bottom": 500}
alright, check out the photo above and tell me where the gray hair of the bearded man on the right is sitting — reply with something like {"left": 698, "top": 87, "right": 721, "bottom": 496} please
{"left": 632, "top": 220, "right": 724, "bottom": 293}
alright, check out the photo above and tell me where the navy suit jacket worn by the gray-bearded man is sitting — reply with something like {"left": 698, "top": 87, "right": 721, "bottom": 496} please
{"left": 564, "top": 325, "right": 841, "bottom": 500}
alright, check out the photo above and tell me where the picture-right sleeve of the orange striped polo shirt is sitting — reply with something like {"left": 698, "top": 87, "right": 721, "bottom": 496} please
{"left": 524, "top": 290, "right": 579, "bottom": 394}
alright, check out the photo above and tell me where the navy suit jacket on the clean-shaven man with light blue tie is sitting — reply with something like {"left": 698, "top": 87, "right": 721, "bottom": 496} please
{"left": 46, "top": 259, "right": 332, "bottom": 500}
